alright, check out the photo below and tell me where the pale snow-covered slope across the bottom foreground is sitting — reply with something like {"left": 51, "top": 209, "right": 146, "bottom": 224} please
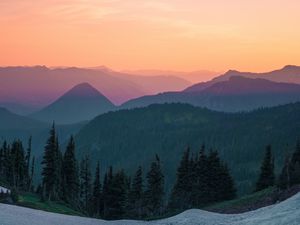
{"left": 0, "top": 194, "right": 300, "bottom": 225}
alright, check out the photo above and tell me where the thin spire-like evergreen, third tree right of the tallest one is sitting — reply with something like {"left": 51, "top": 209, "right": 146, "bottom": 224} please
{"left": 92, "top": 162, "right": 103, "bottom": 217}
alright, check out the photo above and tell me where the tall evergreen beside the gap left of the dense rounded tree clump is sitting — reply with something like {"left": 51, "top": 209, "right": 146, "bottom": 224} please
{"left": 145, "top": 155, "right": 164, "bottom": 216}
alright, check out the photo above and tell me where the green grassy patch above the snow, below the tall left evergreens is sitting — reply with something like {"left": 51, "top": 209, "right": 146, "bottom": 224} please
{"left": 17, "top": 193, "right": 83, "bottom": 216}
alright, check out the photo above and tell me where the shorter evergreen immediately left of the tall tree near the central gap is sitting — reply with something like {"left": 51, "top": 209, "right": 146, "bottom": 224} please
{"left": 129, "top": 166, "right": 144, "bottom": 219}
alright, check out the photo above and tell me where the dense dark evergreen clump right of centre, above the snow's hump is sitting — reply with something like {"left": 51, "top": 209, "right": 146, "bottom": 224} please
{"left": 169, "top": 145, "right": 236, "bottom": 210}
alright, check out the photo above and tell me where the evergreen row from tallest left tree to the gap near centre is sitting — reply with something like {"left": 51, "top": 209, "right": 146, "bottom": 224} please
{"left": 38, "top": 126, "right": 165, "bottom": 219}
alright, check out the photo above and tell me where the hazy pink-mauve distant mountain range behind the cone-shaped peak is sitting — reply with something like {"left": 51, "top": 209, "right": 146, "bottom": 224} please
{"left": 0, "top": 66, "right": 191, "bottom": 109}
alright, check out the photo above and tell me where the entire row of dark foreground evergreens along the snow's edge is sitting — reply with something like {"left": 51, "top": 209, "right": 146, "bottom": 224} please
{"left": 0, "top": 125, "right": 300, "bottom": 219}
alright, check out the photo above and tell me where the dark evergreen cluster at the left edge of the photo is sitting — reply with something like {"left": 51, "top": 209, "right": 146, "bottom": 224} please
{"left": 0, "top": 138, "right": 34, "bottom": 191}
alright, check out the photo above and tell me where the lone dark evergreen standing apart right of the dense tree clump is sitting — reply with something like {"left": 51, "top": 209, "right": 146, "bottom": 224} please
{"left": 256, "top": 145, "right": 275, "bottom": 191}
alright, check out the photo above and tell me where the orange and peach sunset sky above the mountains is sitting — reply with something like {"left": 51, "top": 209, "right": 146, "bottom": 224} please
{"left": 0, "top": 0, "right": 300, "bottom": 71}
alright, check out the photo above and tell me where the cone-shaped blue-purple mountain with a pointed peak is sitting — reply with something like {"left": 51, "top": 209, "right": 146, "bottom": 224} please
{"left": 31, "top": 83, "right": 115, "bottom": 124}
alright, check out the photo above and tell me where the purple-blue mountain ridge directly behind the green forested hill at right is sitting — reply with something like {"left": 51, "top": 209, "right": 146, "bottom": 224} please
{"left": 122, "top": 76, "right": 300, "bottom": 112}
